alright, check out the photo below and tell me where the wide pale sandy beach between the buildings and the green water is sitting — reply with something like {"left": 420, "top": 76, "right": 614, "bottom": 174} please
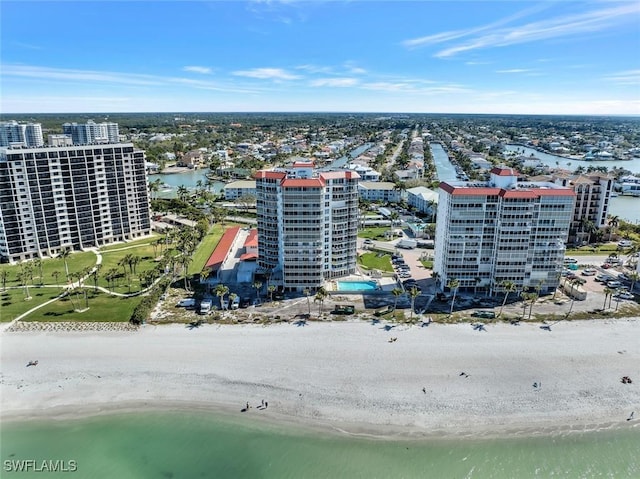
{"left": 0, "top": 319, "right": 640, "bottom": 437}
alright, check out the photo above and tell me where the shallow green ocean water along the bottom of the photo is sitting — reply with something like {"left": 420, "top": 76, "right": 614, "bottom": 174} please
{"left": 0, "top": 411, "right": 640, "bottom": 479}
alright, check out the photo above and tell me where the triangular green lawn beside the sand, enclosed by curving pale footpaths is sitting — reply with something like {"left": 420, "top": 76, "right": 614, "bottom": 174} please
{"left": 24, "top": 292, "right": 142, "bottom": 321}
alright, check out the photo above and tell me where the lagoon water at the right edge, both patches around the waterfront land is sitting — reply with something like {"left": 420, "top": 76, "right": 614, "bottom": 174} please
{"left": 505, "top": 145, "right": 640, "bottom": 224}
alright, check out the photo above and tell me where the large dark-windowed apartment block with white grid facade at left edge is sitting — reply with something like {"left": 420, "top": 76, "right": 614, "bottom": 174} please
{"left": 0, "top": 143, "right": 151, "bottom": 262}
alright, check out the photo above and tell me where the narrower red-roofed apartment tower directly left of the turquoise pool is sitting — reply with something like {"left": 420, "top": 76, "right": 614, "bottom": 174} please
{"left": 256, "top": 162, "right": 359, "bottom": 291}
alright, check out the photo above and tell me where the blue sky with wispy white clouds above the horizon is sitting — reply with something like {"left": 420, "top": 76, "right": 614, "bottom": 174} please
{"left": 0, "top": 0, "right": 640, "bottom": 115}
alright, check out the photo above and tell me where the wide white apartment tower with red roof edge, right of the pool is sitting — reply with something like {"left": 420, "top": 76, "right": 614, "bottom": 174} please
{"left": 434, "top": 168, "right": 576, "bottom": 293}
